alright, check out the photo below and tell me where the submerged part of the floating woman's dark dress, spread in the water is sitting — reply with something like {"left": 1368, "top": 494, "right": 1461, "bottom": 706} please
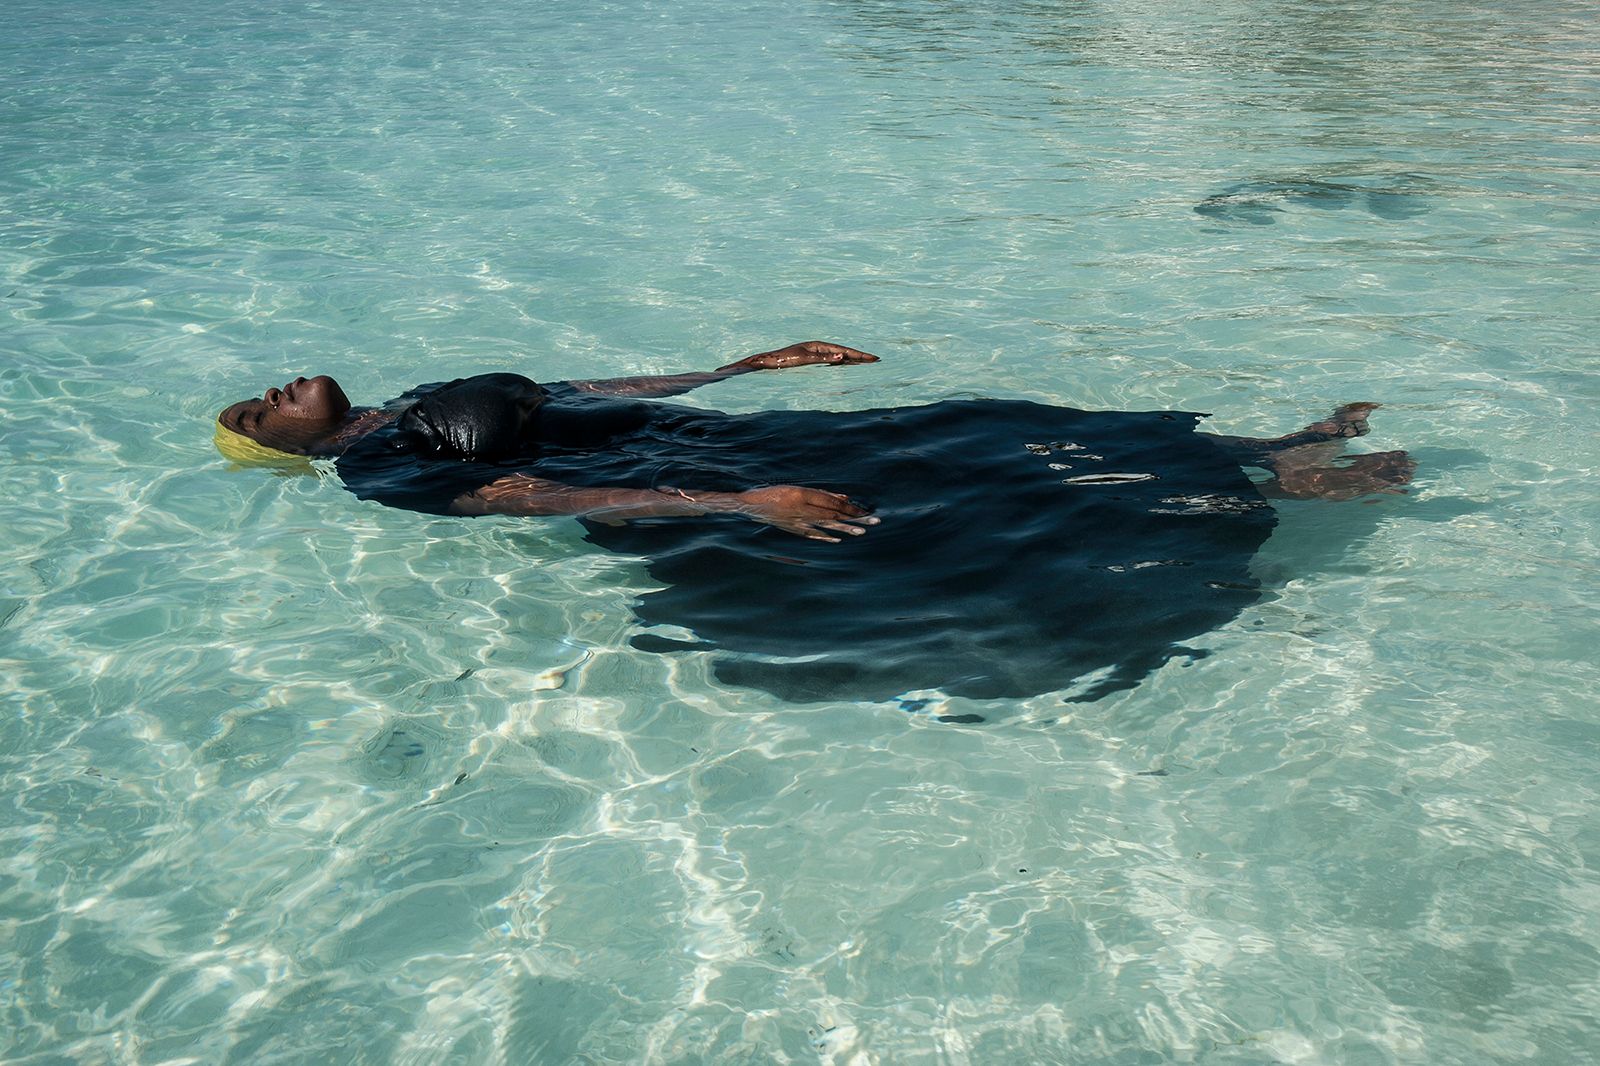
{"left": 338, "top": 377, "right": 1275, "bottom": 699}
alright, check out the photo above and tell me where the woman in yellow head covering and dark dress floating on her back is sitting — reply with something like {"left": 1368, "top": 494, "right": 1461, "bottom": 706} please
{"left": 216, "top": 341, "right": 1416, "bottom": 699}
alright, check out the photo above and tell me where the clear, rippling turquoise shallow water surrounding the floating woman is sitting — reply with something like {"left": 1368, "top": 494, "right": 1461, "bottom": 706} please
{"left": 0, "top": 0, "right": 1600, "bottom": 1063}
